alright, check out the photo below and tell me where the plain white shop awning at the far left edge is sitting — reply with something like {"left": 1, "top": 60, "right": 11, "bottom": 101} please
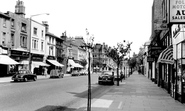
{"left": 0, "top": 55, "right": 19, "bottom": 65}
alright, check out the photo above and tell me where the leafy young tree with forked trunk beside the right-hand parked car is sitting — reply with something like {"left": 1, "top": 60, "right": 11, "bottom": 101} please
{"left": 106, "top": 40, "right": 132, "bottom": 86}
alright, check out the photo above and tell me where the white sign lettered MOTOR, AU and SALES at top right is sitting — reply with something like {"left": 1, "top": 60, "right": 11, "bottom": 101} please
{"left": 169, "top": 0, "right": 185, "bottom": 23}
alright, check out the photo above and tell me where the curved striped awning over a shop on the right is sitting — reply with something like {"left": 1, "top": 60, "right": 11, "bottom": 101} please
{"left": 157, "top": 45, "right": 174, "bottom": 64}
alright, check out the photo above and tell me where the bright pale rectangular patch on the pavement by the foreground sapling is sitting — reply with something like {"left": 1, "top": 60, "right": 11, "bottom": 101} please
{"left": 91, "top": 99, "right": 113, "bottom": 108}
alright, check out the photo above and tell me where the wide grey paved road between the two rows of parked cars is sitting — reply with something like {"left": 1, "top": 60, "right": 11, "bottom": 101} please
{"left": 0, "top": 74, "right": 111, "bottom": 111}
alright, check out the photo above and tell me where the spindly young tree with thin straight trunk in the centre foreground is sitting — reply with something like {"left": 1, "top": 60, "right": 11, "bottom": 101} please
{"left": 81, "top": 29, "right": 94, "bottom": 111}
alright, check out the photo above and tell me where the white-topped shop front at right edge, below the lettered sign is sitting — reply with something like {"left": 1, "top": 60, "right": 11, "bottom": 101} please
{"left": 172, "top": 24, "right": 185, "bottom": 103}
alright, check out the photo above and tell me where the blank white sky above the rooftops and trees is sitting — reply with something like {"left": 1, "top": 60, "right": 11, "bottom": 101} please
{"left": 0, "top": 0, "right": 153, "bottom": 53}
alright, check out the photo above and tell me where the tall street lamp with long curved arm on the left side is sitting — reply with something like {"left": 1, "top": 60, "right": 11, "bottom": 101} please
{"left": 29, "top": 13, "right": 49, "bottom": 71}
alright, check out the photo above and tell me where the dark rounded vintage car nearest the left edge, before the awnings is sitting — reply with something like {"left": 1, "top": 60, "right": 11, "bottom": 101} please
{"left": 12, "top": 69, "right": 37, "bottom": 82}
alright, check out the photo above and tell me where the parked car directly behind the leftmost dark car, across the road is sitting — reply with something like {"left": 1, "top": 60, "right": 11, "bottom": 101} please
{"left": 50, "top": 69, "right": 64, "bottom": 78}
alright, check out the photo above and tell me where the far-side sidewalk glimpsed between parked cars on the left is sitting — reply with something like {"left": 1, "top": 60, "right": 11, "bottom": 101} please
{"left": 0, "top": 74, "right": 71, "bottom": 83}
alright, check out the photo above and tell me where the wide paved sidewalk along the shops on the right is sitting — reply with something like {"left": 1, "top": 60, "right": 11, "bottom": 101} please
{"left": 77, "top": 72, "right": 185, "bottom": 111}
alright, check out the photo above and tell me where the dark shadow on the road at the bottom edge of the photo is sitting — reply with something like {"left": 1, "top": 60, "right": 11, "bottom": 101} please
{"left": 35, "top": 105, "right": 77, "bottom": 111}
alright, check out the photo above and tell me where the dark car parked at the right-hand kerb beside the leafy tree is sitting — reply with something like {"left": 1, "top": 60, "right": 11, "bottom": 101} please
{"left": 98, "top": 71, "right": 114, "bottom": 85}
